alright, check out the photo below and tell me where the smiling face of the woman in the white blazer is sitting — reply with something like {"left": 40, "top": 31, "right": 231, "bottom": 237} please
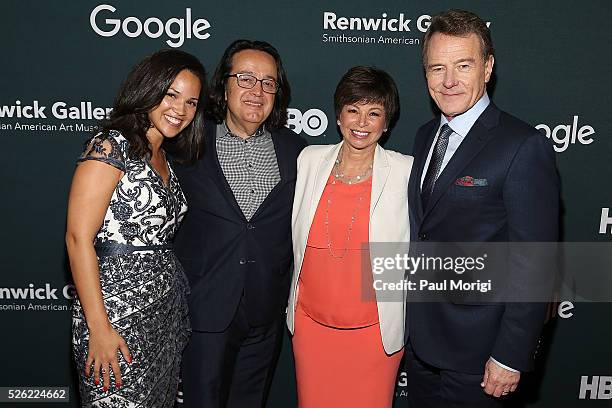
{"left": 338, "top": 102, "right": 386, "bottom": 151}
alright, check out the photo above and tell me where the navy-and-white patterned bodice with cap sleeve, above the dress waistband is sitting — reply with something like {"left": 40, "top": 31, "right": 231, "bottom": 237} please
{"left": 79, "top": 130, "right": 187, "bottom": 246}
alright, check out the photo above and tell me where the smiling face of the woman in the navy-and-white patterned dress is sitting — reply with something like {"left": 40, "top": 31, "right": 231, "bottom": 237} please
{"left": 147, "top": 69, "right": 202, "bottom": 143}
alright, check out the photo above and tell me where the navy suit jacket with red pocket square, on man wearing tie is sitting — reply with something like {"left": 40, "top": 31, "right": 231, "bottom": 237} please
{"left": 407, "top": 103, "right": 559, "bottom": 374}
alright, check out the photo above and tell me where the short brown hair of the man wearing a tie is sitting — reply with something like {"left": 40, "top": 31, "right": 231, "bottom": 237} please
{"left": 422, "top": 9, "right": 494, "bottom": 66}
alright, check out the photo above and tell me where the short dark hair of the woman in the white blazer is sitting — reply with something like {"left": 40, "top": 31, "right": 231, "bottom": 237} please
{"left": 334, "top": 66, "right": 399, "bottom": 127}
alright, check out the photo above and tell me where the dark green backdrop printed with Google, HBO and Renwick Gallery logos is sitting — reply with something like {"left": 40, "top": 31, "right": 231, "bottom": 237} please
{"left": 0, "top": 0, "right": 612, "bottom": 408}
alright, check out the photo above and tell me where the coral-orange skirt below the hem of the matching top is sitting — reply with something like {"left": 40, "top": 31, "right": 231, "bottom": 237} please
{"left": 293, "top": 302, "right": 404, "bottom": 408}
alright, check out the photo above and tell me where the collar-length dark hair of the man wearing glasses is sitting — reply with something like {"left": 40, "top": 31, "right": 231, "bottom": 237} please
{"left": 206, "top": 40, "right": 291, "bottom": 129}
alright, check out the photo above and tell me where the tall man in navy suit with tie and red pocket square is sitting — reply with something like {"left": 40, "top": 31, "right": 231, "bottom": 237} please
{"left": 406, "top": 10, "right": 559, "bottom": 408}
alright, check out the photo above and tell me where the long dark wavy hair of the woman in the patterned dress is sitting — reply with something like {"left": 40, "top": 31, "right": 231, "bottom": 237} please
{"left": 101, "top": 49, "right": 206, "bottom": 161}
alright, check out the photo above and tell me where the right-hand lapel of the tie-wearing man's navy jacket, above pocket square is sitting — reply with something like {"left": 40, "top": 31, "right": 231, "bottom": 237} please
{"left": 423, "top": 103, "right": 499, "bottom": 217}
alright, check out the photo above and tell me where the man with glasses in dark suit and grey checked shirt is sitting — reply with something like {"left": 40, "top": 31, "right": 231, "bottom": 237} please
{"left": 175, "top": 40, "right": 306, "bottom": 408}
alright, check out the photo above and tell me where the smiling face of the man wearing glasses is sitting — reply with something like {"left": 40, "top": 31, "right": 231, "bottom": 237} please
{"left": 225, "top": 50, "right": 278, "bottom": 138}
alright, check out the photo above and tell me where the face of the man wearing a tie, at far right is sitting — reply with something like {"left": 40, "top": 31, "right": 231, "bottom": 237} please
{"left": 425, "top": 33, "right": 494, "bottom": 120}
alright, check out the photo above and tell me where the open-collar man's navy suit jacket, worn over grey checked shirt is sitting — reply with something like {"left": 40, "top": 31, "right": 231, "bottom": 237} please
{"left": 174, "top": 121, "right": 306, "bottom": 332}
